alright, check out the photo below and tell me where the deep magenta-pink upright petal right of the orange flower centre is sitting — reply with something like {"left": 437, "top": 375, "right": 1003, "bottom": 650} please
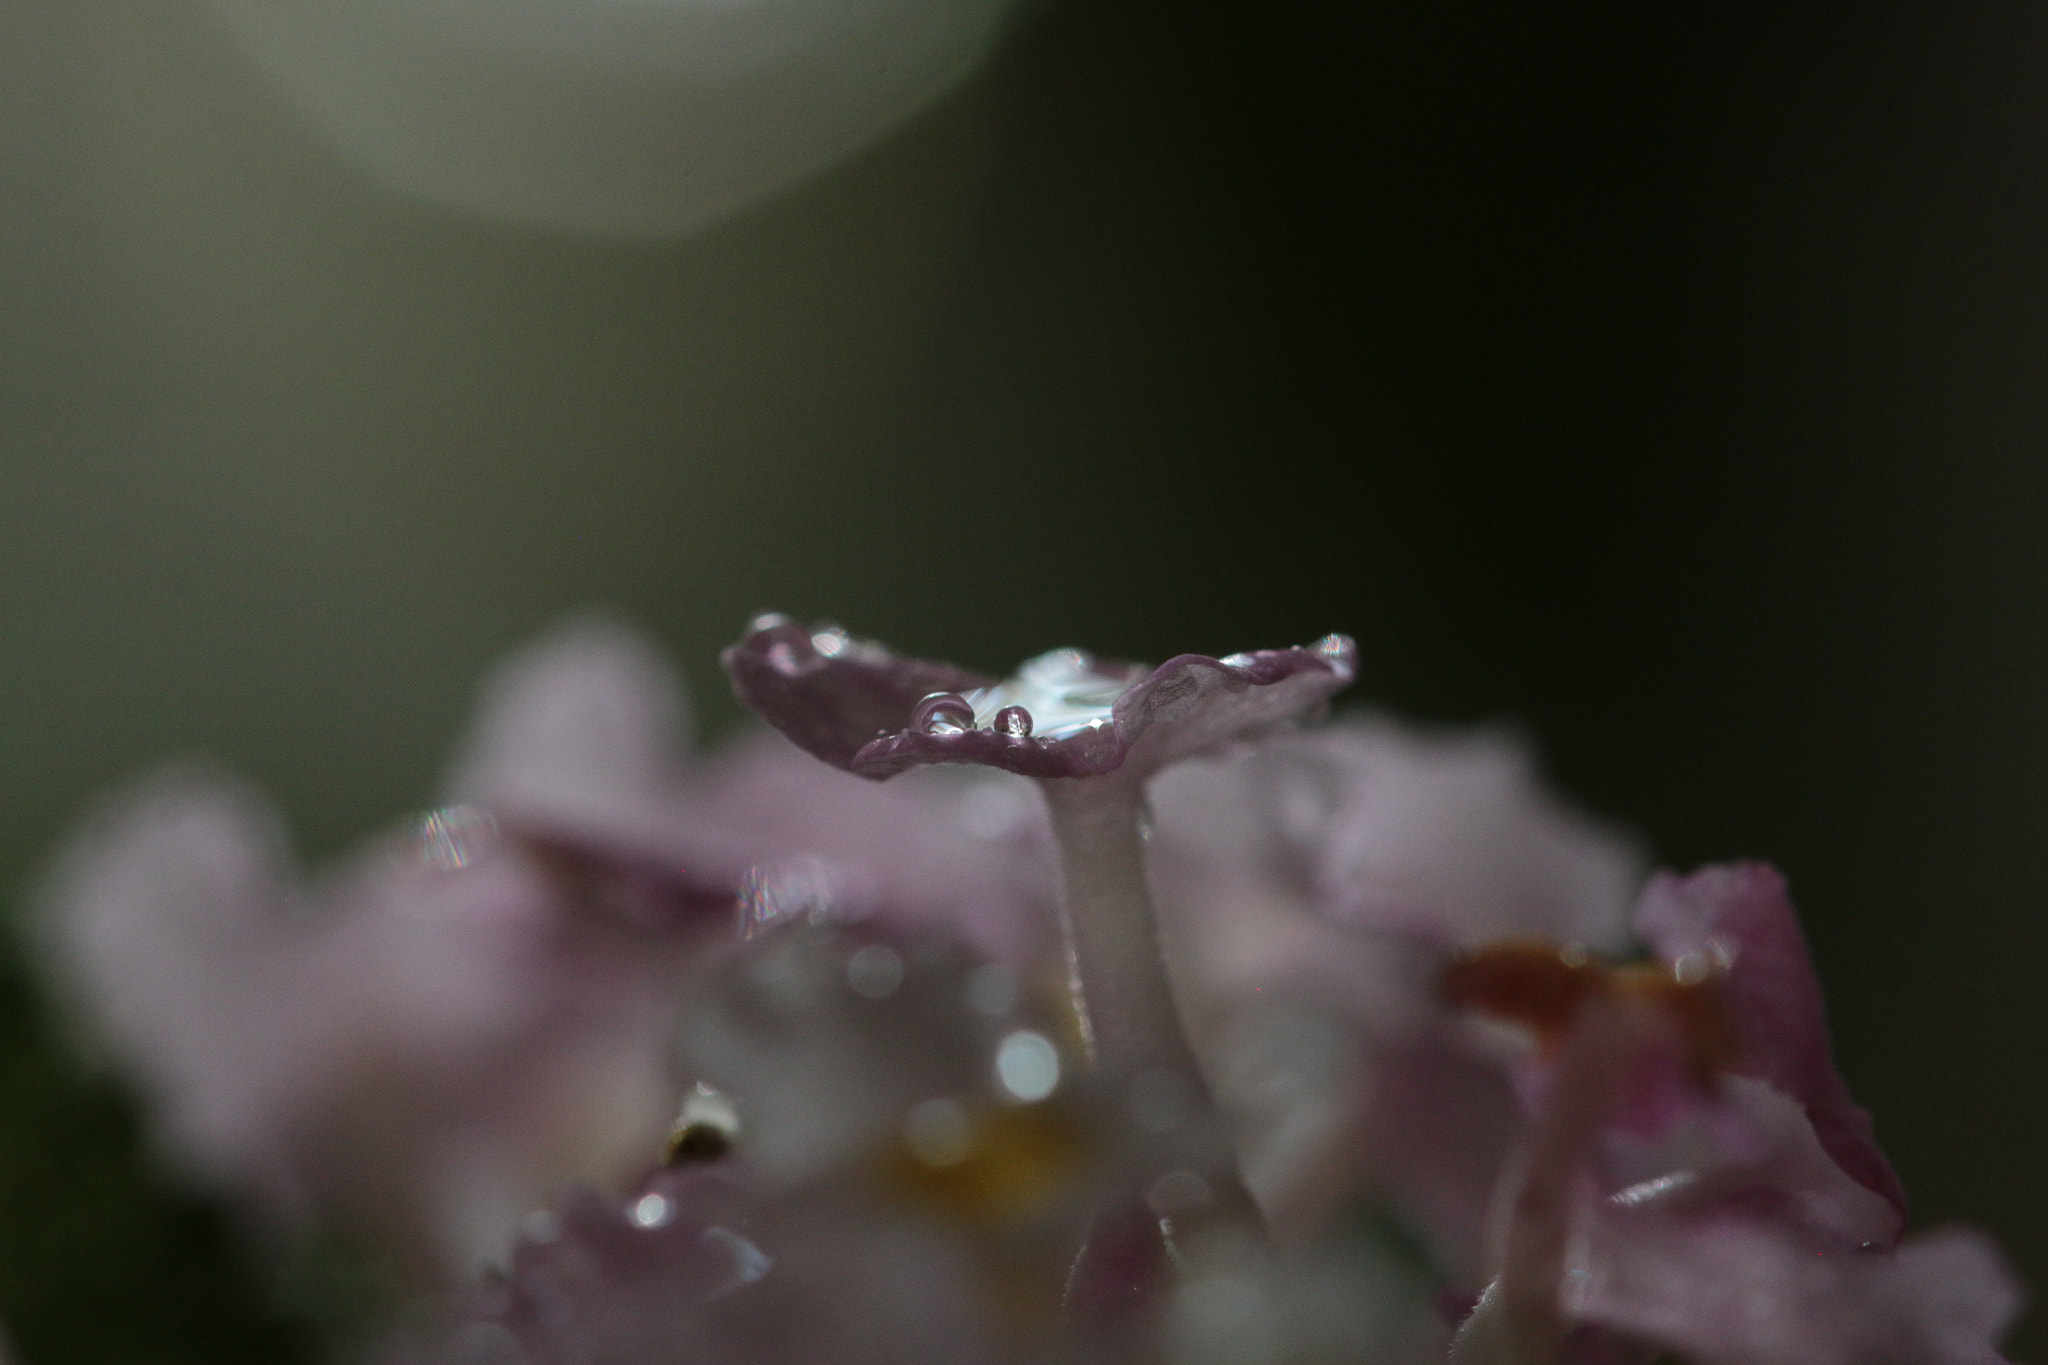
{"left": 1636, "top": 864, "right": 1907, "bottom": 1220}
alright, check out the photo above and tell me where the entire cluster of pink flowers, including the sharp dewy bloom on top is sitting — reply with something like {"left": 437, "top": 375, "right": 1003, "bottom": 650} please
{"left": 43, "top": 616, "right": 2017, "bottom": 1365}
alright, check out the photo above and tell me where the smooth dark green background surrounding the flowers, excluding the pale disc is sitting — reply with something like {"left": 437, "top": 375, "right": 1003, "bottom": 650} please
{"left": 0, "top": 0, "right": 2048, "bottom": 1365}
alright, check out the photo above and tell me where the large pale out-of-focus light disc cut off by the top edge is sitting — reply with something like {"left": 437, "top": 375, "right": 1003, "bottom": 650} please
{"left": 213, "top": 0, "right": 1008, "bottom": 235}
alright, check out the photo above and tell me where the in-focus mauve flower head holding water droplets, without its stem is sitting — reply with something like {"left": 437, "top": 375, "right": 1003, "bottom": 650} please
{"left": 725, "top": 616, "right": 1358, "bottom": 778}
